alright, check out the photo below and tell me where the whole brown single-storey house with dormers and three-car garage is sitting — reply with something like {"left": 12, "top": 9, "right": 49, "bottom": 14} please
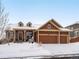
{"left": 6, "top": 19, "right": 70, "bottom": 43}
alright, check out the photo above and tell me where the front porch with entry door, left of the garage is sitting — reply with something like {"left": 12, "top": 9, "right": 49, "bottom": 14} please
{"left": 13, "top": 30, "right": 34, "bottom": 42}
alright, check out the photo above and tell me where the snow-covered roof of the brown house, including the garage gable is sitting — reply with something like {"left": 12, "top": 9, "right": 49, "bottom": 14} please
{"left": 6, "top": 19, "right": 71, "bottom": 31}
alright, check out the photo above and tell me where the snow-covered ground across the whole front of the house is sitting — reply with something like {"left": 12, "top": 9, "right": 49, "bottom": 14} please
{"left": 0, "top": 42, "right": 79, "bottom": 58}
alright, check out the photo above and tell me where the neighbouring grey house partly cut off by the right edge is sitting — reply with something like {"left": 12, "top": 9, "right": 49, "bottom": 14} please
{"left": 66, "top": 22, "right": 79, "bottom": 37}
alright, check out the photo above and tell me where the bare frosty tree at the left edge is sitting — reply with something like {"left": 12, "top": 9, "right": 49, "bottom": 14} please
{"left": 0, "top": 0, "right": 8, "bottom": 39}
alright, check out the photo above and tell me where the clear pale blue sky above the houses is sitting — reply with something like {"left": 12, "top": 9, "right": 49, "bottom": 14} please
{"left": 2, "top": 0, "right": 79, "bottom": 27}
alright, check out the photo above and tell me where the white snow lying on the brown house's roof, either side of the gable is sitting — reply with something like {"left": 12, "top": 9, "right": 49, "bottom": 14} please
{"left": 6, "top": 21, "right": 71, "bottom": 31}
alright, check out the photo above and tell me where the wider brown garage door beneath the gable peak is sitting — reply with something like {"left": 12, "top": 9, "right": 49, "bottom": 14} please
{"left": 39, "top": 31, "right": 58, "bottom": 43}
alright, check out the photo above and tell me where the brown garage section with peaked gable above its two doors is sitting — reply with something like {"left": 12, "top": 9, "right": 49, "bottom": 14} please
{"left": 36, "top": 20, "right": 69, "bottom": 43}
